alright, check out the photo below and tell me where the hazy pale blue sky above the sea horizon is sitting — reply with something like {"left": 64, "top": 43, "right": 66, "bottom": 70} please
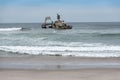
{"left": 0, "top": 0, "right": 120, "bottom": 23}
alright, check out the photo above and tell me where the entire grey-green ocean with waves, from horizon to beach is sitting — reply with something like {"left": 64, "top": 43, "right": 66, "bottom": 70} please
{"left": 0, "top": 22, "right": 120, "bottom": 58}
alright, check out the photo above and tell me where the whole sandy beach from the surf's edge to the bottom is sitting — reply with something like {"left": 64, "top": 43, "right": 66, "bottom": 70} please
{"left": 0, "top": 56, "right": 120, "bottom": 80}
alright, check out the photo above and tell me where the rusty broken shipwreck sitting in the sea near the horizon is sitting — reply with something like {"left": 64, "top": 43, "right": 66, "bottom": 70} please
{"left": 41, "top": 14, "right": 72, "bottom": 29}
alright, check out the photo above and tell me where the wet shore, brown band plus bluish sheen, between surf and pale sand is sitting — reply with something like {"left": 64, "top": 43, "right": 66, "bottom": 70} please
{"left": 0, "top": 56, "right": 120, "bottom": 70}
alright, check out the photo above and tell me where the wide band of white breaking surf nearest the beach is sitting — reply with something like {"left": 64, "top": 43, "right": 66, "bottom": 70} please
{"left": 0, "top": 45, "right": 120, "bottom": 57}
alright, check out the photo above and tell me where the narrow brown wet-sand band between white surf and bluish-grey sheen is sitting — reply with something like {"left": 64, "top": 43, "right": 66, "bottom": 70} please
{"left": 0, "top": 55, "right": 120, "bottom": 62}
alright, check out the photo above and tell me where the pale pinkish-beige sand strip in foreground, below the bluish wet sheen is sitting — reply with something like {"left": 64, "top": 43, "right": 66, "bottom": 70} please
{"left": 0, "top": 68, "right": 120, "bottom": 80}
